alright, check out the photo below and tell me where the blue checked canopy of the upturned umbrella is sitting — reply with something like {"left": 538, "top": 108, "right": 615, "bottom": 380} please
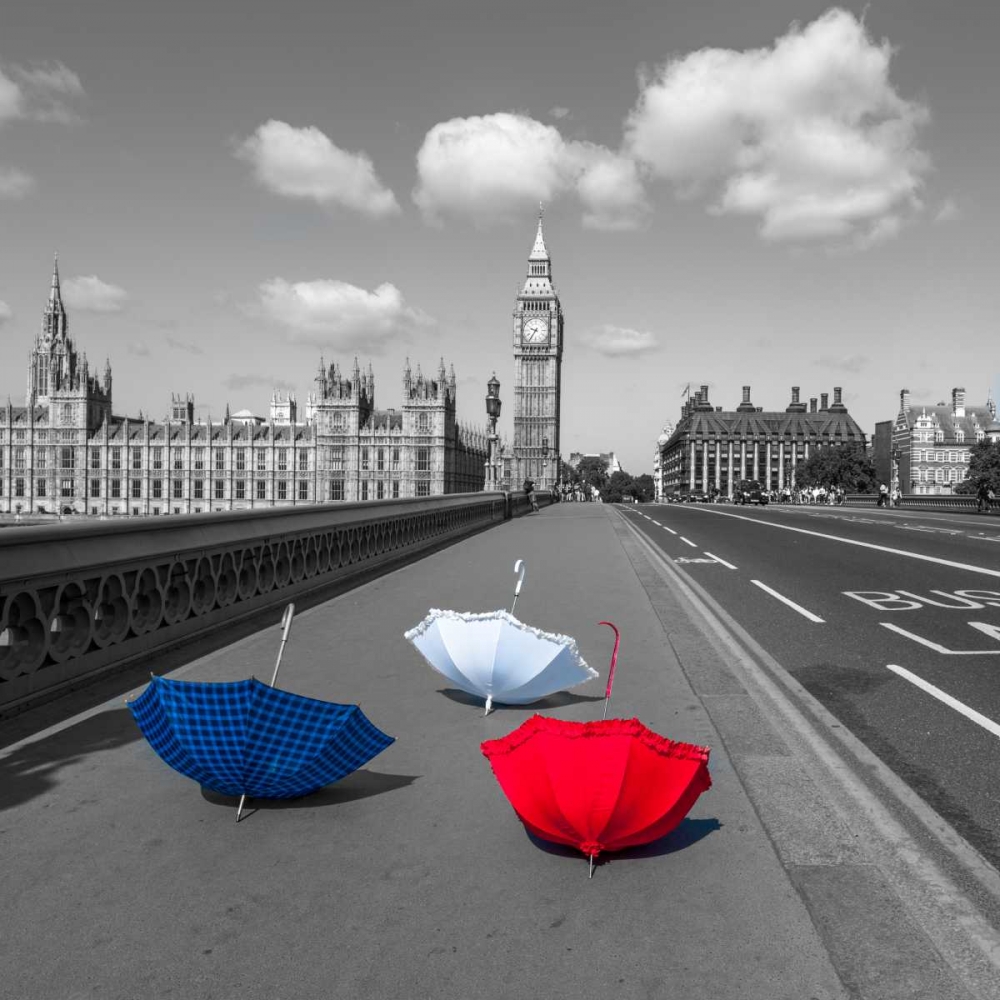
{"left": 129, "top": 677, "right": 394, "bottom": 799}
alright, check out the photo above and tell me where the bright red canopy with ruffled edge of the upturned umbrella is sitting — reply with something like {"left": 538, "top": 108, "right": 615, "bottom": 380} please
{"left": 481, "top": 715, "right": 712, "bottom": 858}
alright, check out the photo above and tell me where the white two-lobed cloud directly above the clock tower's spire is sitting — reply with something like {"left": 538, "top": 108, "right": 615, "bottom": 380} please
{"left": 413, "top": 112, "right": 648, "bottom": 229}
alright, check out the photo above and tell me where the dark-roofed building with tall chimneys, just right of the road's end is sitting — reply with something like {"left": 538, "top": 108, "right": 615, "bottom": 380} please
{"left": 657, "top": 385, "right": 865, "bottom": 496}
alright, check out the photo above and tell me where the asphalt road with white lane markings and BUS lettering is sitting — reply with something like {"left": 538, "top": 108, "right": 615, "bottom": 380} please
{"left": 622, "top": 504, "right": 1000, "bottom": 868}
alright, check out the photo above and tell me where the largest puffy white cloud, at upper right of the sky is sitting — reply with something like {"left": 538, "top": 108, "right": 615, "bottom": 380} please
{"left": 625, "top": 9, "right": 929, "bottom": 245}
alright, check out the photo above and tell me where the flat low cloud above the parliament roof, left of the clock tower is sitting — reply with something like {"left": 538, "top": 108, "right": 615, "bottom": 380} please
{"left": 258, "top": 278, "right": 432, "bottom": 351}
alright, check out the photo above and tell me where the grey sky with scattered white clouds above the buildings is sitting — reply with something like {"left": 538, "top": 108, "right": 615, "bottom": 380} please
{"left": 0, "top": 0, "right": 1000, "bottom": 475}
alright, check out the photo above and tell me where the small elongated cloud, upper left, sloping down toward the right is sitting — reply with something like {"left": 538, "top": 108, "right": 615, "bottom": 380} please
{"left": 236, "top": 119, "right": 399, "bottom": 218}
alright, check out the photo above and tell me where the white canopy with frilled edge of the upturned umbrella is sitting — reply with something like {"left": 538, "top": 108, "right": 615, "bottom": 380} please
{"left": 405, "top": 608, "right": 597, "bottom": 706}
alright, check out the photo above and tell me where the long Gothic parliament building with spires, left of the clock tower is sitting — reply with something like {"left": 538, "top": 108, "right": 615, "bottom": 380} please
{"left": 0, "top": 260, "right": 488, "bottom": 516}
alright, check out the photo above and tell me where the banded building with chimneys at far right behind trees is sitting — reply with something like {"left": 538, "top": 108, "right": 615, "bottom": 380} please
{"left": 890, "top": 388, "right": 1000, "bottom": 494}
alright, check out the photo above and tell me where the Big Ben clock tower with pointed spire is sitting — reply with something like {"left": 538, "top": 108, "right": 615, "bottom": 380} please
{"left": 511, "top": 209, "right": 563, "bottom": 489}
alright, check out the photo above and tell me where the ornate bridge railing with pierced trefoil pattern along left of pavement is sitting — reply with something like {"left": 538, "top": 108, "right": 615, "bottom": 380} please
{"left": 0, "top": 491, "right": 551, "bottom": 714}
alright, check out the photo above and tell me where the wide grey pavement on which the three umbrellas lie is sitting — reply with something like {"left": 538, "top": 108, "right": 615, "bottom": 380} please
{"left": 0, "top": 504, "right": 1000, "bottom": 1000}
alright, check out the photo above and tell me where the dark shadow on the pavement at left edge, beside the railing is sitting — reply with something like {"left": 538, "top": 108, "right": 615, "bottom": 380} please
{"left": 0, "top": 708, "right": 142, "bottom": 809}
